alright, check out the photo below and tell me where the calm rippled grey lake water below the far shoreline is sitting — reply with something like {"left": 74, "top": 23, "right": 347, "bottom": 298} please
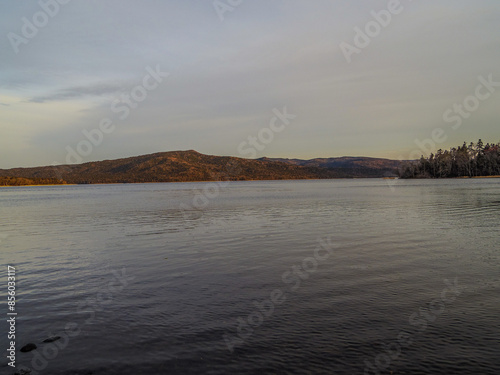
{"left": 0, "top": 179, "right": 500, "bottom": 375}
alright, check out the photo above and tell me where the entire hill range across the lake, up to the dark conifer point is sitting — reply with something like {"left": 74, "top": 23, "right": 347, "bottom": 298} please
{"left": 0, "top": 150, "right": 400, "bottom": 184}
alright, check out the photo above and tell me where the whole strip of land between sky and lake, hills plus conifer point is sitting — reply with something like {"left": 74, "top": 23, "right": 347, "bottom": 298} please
{"left": 0, "top": 140, "right": 500, "bottom": 186}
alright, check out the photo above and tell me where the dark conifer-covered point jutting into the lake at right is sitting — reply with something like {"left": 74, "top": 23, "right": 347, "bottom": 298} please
{"left": 400, "top": 140, "right": 500, "bottom": 178}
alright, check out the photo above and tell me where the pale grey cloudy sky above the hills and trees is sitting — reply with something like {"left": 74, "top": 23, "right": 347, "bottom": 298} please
{"left": 0, "top": 0, "right": 500, "bottom": 168}
